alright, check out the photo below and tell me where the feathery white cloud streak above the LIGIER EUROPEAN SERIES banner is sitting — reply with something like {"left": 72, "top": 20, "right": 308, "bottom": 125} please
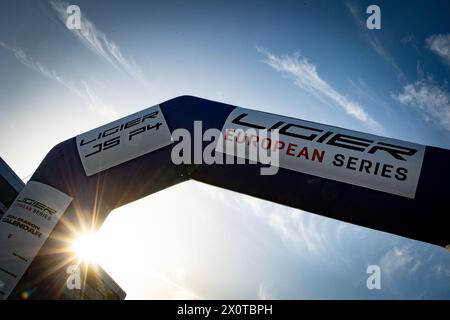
{"left": 257, "top": 48, "right": 381, "bottom": 129}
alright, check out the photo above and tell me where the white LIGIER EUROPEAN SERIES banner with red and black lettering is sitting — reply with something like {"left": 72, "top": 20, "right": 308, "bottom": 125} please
{"left": 216, "top": 108, "right": 425, "bottom": 198}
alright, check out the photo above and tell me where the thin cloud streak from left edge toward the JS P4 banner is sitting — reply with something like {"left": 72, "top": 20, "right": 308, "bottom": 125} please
{"left": 0, "top": 41, "right": 118, "bottom": 119}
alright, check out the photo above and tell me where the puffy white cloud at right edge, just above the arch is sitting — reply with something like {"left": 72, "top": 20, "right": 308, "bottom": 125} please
{"left": 392, "top": 77, "right": 450, "bottom": 130}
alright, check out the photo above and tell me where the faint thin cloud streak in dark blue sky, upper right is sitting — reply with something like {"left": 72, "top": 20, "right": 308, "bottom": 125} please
{"left": 346, "top": 2, "right": 403, "bottom": 76}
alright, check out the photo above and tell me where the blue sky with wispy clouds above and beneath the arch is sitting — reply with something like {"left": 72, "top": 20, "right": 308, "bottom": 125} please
{"left": 0, "top": 0, "right": 450, "bottom": 299}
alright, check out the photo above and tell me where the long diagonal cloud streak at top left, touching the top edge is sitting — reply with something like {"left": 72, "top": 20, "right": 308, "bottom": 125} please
{"left": 50, "top": 0, "right": 146, "bottom": 82}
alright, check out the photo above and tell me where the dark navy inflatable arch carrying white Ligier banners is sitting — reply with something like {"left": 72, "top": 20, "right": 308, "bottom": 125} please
{"left": 0, "top": 96, "right": 450, "bottom": 299}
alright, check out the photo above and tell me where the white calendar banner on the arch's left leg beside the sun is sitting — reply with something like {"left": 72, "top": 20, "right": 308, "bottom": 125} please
{"left": 0, "top": 181, "right": 72, "bottom": 299}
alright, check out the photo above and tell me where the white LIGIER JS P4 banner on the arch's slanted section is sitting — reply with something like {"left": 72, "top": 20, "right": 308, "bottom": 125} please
{"left": 76, "top": 105, "right": 172, "bottom": 176}
